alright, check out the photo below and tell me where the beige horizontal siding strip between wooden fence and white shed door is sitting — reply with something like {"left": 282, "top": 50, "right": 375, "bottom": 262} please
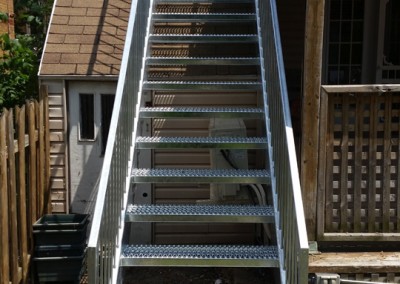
{"left": 41, "top": 80, "right": 69, "bottom": 213}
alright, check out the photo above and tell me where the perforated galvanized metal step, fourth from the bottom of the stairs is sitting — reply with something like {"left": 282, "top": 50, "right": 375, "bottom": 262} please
{"left": 136, "top": 137, "right": 267, "bottom": 149}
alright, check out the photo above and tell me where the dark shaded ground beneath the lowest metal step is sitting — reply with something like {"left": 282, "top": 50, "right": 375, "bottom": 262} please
{"left": 123, "top": 267, "right": 274, "bottom": 284}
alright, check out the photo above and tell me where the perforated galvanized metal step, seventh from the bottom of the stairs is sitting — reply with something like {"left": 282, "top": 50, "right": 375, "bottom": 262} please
{"left": 146, "top": 57, "right": 260, "bottom": 65}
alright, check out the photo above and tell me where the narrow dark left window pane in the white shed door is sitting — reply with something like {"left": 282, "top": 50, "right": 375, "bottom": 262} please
{"left": 79, "top": 94, "right": 95, "bottom": 141}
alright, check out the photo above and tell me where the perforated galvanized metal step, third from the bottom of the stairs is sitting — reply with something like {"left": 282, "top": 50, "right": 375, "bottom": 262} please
{"left": 131, "top": 168, "right": 270, "bottom": 184}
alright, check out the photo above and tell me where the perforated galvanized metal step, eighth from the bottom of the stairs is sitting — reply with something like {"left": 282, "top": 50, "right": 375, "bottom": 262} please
{"left": 149, "top": 34, "right": 258, "bottom": 43}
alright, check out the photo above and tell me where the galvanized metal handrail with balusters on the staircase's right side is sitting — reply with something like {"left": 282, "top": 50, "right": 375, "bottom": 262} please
{"left": 256, "top": 0, "right": 309, "bottom": 284}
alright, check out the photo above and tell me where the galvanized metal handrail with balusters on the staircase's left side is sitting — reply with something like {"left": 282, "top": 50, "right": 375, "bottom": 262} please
{"left": 87, "top": 0, "right": 153, "bottom": 284}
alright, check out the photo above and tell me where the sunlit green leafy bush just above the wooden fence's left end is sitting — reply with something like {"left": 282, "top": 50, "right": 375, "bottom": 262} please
{"left": 0, "top": 34, "right": 38, "bottom": 108}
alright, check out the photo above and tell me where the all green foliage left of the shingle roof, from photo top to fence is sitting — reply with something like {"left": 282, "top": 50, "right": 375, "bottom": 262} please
{"left": 0, "top": 0, "right": 54, "bottom": 111}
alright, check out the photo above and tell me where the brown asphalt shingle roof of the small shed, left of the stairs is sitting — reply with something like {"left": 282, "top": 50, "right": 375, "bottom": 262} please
{"left": 39, "top": 0, "right": 131, "bottom": 76}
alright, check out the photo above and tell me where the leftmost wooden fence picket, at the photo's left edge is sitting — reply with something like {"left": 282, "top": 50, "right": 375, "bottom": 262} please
{"left": 0, "top": 110, "right": 10, "bottom": 283}
